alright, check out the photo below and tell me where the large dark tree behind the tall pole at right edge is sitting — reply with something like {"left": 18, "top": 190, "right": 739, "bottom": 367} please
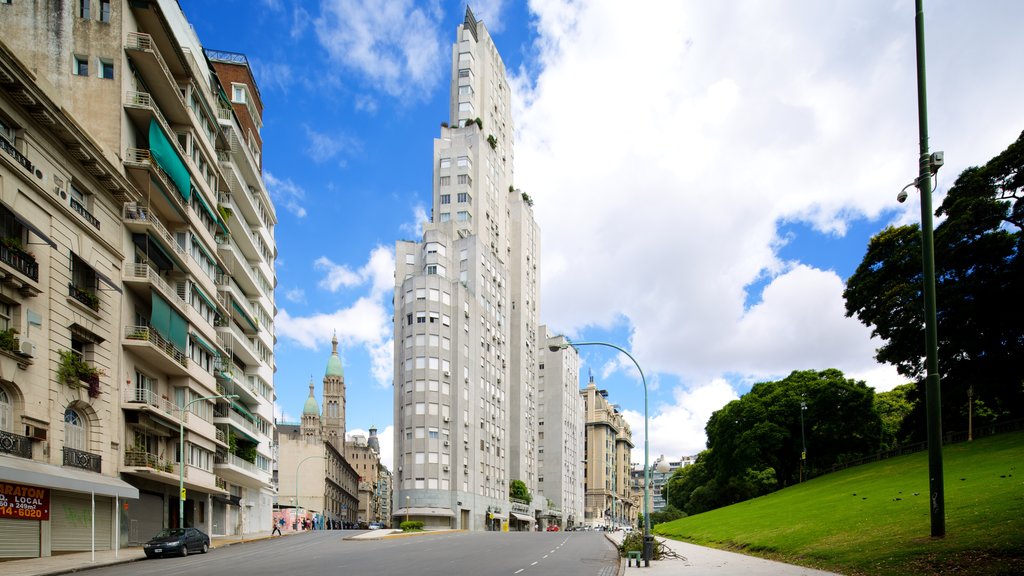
{"left": 844, "top": 127, "right": 1024, "bottom": 439}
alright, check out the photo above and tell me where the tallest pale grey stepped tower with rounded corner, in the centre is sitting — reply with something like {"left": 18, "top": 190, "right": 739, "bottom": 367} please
{"left": 392, "top": 8, "right": 540, "bottom": 530}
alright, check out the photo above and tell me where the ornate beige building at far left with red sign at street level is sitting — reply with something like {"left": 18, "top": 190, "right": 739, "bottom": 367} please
{"left": 0, "top": 39, "right": 139, "bottom": 560}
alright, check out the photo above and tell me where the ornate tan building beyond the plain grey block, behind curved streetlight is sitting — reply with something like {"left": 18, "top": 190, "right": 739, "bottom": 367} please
{"left": 580, "top": 375, "right": 637, "bottom": 526}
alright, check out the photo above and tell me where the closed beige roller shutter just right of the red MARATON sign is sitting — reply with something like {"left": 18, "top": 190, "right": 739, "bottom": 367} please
{"left": 50, "top": 494, "right": 114, "bottom": 552}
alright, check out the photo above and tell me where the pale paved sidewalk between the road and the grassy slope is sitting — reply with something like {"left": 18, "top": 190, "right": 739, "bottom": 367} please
{"left": 605, "top": 532, "right": 838, "bottom": 576}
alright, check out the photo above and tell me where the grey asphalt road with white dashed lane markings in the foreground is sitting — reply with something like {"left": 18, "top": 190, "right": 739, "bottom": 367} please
{"left": 77, "top": 531, "right": 618, "bottom": 576}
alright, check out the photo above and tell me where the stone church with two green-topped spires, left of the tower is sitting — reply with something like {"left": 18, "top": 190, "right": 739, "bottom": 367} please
{"left": 274, "top": 336, "right": 360, "bottom": 529}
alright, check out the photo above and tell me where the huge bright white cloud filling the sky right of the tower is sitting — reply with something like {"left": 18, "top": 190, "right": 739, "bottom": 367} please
{"left": 513, "top": 0, "right": 1024, "bottom": 407}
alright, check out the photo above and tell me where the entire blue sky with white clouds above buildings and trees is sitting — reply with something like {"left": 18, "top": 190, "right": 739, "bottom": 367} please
{"left": 179, "top": 0, "right": 1024, "bottom": 469}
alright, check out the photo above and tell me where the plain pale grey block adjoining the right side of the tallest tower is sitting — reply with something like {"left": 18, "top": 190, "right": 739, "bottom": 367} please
{"left": 535, "top": 326, "right": 587, "bottom": 530}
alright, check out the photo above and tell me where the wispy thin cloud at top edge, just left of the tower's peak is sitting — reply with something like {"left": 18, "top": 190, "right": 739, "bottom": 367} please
{"left": 313, "top": 0, "right": 442, "bottom": 99}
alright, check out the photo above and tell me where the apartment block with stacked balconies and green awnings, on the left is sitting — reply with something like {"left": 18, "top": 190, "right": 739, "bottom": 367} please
{"left": 0, "top": 0, "right": 276, "bottom": 545}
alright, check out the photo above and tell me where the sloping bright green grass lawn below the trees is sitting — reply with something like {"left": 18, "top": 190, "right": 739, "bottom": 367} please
{"left": 653, "top": 433, "right": 1024, "bottom": 576}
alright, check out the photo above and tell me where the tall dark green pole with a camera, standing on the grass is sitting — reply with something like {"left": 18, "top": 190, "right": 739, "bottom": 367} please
{"left": 904, "top": 0, "right": 946, "bottom": 538}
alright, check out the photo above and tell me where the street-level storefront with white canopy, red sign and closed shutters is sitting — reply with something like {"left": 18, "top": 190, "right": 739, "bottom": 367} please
{"left": 0, "top": 455, "right": 138, "bottom": 559}
